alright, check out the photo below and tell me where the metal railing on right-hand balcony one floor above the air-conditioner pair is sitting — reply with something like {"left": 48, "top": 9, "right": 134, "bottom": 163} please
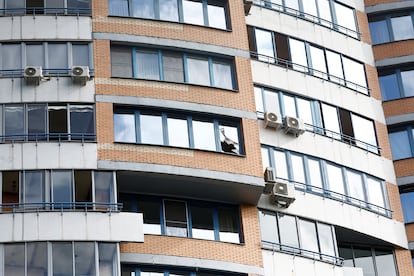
{"left": 250, "top": 52, "right": 371, "bottom": 95}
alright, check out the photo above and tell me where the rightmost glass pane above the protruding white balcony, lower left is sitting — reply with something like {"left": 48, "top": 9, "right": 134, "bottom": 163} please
{"left": 94, "top": 171, "right": 115, "bottom": 207}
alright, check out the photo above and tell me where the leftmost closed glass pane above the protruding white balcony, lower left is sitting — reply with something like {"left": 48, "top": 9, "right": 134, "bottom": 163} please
{"left": 23, "top": 171, "right": 45, "bottom": 205}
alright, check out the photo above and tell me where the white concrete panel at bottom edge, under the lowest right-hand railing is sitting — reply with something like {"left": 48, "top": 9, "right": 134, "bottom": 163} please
{"left": 262, "top": 250, "right": 363, "bottom": 276}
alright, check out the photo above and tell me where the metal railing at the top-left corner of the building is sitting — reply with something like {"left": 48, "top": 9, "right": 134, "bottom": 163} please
{"left": 0, "top": 7, "right": 92, "bottom": 16}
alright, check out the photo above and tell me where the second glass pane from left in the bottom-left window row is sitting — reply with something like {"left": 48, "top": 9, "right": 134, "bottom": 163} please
{"left": 27, "top": 242, "right": 48, "bottom": 276}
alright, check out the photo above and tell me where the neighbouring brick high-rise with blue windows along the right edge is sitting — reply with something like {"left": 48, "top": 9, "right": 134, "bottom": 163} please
{"left": 366, "top": 1, "right": 414, "bottom": 270}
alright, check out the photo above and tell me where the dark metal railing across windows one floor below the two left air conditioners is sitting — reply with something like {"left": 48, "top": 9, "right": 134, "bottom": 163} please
{"left": 0, "top": 133, "right": 96, "bottom": 144}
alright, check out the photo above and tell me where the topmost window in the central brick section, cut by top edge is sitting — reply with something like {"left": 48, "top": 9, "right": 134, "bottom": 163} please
{"left": 109, "top": 0, "right": 229, "bottom": 30}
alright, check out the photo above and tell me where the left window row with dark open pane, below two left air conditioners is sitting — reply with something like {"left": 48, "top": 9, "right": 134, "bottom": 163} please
{"left": 0, "top": 104, "right": 95, "bottom": 141}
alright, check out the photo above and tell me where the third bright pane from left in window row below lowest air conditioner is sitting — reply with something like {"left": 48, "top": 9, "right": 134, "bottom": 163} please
{"left": 298, "top": 219, "right": 319, "bottom": 258}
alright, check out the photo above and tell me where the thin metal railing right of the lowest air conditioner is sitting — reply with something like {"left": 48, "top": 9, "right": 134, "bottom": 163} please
{"left": 276, "top": 177, "right": 393, "bottom": 218}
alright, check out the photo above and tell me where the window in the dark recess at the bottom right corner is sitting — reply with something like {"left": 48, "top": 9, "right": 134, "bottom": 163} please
{"left": 339, "top": 245, "right": 397, "bottom": 276}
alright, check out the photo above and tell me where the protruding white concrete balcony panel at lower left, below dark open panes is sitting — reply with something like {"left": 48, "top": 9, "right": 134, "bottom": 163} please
{"left": 0, "top": 211, "right": 144, "bottom": 242}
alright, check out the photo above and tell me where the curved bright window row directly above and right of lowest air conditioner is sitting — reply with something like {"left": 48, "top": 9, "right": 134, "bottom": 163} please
{"left": 262, "top": 146, "right": 391, "bottom": 216}
